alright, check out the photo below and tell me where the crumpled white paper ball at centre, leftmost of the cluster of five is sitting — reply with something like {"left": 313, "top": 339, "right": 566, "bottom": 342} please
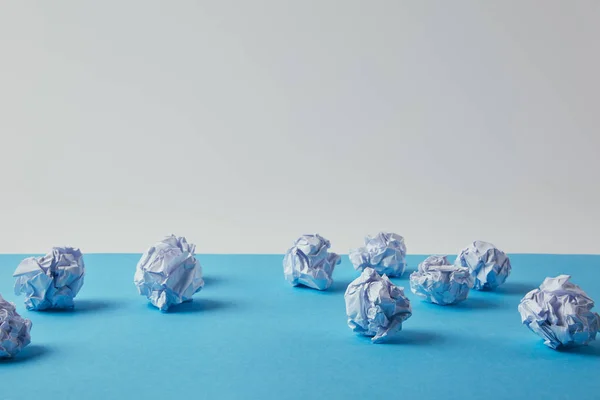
{"left": 283, "top": 234, "right": 340, "bottom": 290}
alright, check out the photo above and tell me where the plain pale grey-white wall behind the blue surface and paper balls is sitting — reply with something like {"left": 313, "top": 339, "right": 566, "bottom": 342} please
{"left": 0, "top": 0, "right": 600, "bottom": 253}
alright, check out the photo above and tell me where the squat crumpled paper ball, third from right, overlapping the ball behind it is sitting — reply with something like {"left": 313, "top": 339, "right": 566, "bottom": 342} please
{"left": 410, "top": 256, "right": 473, "bottom": 306}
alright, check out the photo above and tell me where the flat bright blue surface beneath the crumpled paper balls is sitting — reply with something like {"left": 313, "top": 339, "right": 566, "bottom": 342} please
{"left": 0, "top": 254, "right": 600, "bottom": 400}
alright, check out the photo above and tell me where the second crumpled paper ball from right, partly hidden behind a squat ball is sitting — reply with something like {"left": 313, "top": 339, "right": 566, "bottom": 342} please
{"left": 454, "top": 240, "right": 511, "bottom": 290}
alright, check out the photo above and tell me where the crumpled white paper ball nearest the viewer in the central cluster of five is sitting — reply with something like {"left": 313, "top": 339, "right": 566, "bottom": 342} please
{"left": 344, "top": 268, "right": 412, "bottom": 343}
